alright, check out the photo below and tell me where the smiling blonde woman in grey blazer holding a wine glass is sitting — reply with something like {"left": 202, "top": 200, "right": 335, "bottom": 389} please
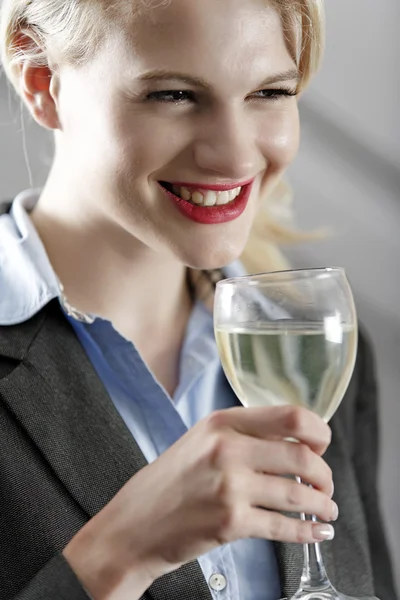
{"left": 0, "top": 0, "right": 394, "bottom": 600}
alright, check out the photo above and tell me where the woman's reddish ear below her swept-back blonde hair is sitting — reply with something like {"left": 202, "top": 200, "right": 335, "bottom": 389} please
{"left": 17, "top": 32, "right": 60, "bottom": 129}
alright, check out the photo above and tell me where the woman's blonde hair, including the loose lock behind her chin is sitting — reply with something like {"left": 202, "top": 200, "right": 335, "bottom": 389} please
{"left": 0, "top": 0, "right": 325, "bottom": 272}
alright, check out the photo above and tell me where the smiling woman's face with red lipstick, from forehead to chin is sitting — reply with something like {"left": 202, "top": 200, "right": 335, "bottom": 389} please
{"left": 50, "top": 0, "right": 298, "bottom": 268}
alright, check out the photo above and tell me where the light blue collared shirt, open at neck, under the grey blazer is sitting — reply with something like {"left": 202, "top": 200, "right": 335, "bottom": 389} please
{"left": 0, "top": 191, "right": 281, "bottom": 600}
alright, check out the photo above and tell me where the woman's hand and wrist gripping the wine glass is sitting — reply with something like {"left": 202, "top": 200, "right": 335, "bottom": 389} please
{"left": 64, "top": 406, "right": 337, "bottom": 600}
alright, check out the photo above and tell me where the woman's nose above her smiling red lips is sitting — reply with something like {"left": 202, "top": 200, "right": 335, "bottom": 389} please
{"left": 194, "top": 108, "right": 265, "bottom": 181}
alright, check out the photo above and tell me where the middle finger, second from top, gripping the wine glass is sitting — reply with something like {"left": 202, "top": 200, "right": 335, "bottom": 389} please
{"left": 238, "top": 436, "right": 333, "bottom": 497}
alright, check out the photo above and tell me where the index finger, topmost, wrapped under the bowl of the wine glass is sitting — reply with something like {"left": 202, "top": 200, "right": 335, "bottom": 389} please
{"left": 219, "top": 406, "right": 331, "bottom": 455}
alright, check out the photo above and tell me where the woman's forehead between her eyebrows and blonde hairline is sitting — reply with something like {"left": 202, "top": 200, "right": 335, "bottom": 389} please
{"left": 111, "top": 0, "right": 294, "bottom": 84}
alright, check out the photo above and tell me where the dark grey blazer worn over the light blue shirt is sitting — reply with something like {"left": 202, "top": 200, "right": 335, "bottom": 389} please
{"left": 0, "top": 301, "right": 396, "bottom": 600}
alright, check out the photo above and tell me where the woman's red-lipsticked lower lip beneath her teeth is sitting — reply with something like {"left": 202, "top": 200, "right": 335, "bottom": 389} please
{"left": 159, "top": 182, "right": 253, "bottom": 225}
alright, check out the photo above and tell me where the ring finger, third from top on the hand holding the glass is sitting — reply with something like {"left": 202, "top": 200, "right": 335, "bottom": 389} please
{"left": 248, "top": 474, "right": 339, "bottom": 521}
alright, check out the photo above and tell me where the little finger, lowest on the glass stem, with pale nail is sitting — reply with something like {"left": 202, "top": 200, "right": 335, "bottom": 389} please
{"left": 247, "top": 508, "right": 335, "bottom": 544}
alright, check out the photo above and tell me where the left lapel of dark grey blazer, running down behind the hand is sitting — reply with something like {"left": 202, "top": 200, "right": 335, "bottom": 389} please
{"left": 0, "top": 301, "right": 211, "bottom": 600}
